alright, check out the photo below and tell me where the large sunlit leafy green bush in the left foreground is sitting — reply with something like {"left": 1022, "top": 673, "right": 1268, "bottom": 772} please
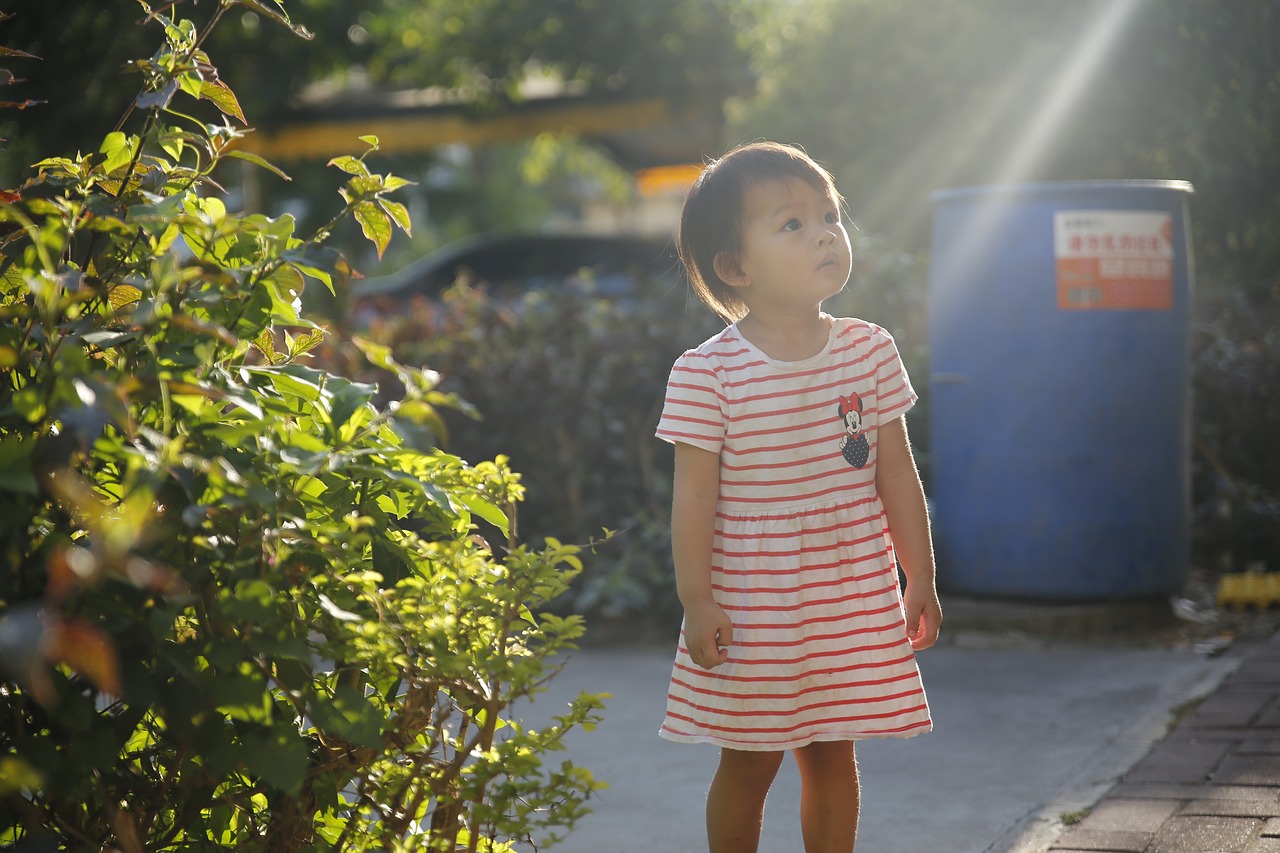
{"left": 0, "top": 0, "right": 600, "bottom": 853}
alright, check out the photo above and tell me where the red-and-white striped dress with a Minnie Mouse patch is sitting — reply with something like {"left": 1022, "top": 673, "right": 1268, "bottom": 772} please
{"left": 657, "top": 319, "right": 932, "bottom": 751}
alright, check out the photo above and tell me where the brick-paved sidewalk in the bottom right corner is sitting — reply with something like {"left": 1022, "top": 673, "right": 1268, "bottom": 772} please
{"left": 1048, "top": 625, "right": 1280, "bottom": 853}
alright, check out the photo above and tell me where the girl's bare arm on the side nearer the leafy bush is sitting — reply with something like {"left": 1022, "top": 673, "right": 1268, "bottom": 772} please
{"left": 671, "top": 442, "right": 733, "bottom": 670}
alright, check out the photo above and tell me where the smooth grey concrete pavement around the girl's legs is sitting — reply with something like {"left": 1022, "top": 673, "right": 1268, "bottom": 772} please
{"left": 517, "top": 604, "right": 1239, "bottom": 853}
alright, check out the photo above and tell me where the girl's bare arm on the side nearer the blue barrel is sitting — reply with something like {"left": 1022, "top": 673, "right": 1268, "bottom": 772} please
{"left": 876, "top": 416, "right": 942, "bottom": 649}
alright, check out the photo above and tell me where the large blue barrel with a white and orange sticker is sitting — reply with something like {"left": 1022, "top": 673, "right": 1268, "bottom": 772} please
{"left": 929, "top": 181, "right": 1192, "bottom": 602}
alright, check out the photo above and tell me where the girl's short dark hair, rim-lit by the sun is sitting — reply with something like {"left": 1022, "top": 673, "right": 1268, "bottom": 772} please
{"left": 676, "top": 142, "right": 844, "bottom": 323}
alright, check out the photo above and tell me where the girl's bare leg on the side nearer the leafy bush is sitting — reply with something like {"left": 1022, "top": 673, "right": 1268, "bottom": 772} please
{"left": 707, "top": 749, "right": 785, "bottom": 853}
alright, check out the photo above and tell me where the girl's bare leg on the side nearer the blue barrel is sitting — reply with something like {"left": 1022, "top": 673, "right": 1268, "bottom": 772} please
{"left": 795, "top": 740, "right": 859, "bottom": 853}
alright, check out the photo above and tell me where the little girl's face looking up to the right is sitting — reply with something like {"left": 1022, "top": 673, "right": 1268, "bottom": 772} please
{"left": 717, "top": 179, "right": 852, "bottom": 311}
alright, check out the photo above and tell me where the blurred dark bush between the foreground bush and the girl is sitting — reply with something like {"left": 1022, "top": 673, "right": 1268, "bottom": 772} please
{"left": 355, "top": 282, "right": 719, "bottom": 617}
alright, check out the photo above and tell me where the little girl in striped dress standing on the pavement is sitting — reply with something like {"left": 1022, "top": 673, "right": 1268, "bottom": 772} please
{"left": 658, "top": 142, "right": 942, "bottom": 853}
